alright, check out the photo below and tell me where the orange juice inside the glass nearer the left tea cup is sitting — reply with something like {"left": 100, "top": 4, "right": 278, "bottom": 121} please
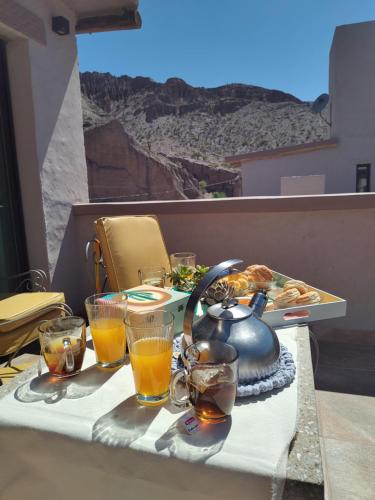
{"left": 90, "top": 318, "right": 126, "bottom": 363}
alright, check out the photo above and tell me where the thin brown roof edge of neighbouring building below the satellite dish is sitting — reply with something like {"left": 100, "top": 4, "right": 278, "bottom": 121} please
{"left": 225, "top": 138, "right": 338, "bottom": 167}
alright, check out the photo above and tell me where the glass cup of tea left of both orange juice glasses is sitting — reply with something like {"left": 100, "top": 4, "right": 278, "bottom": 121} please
{"left": 38, "top": 316, "right": 86, "bottom": 378}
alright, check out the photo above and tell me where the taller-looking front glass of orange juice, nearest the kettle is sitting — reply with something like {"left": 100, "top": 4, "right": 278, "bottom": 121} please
{"left": 125, "top": 309, "right": 174, "bottom": 406}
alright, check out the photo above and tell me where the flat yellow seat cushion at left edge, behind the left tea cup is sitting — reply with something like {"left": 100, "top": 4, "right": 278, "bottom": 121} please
{"left": 0, "top": 292, "right": 65, "bottom": 333}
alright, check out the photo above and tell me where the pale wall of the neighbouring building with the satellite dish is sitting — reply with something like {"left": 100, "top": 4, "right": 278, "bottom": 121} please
{"left": 241, "top": 21, "right": 375, "bottom": 196}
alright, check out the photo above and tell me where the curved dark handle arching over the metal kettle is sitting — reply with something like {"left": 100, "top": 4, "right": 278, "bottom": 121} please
{"left": 184, "top": 259, "right": 243, "bottom": 339}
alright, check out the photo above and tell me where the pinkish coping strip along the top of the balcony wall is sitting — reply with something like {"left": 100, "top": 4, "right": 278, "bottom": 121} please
{"left": 73, "top": 193, "right": 375, "bottom": 216}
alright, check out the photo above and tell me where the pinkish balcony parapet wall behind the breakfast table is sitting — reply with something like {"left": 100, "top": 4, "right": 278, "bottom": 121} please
{"left": 71, "top": 194, "right": 375, "bottom": 334}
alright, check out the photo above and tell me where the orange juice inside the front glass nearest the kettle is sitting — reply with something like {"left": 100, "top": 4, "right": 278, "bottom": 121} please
{"left": 130, "top": 337, "right": 172, "bottom": 397}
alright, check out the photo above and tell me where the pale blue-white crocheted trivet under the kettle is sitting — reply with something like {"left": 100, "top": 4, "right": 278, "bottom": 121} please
{"left": 172, "top": 335, "right": 296, "bottom": 398}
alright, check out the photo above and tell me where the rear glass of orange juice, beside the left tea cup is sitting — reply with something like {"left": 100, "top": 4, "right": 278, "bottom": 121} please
{"left": 85, "top": 292, "right": 128, "bottom": 368}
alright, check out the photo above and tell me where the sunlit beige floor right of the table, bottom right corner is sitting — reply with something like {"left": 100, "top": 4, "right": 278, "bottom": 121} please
{"left": 316, "top": 390, "right": 375, "bottom": 500}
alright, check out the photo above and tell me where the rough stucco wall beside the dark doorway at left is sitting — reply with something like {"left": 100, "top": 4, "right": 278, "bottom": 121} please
{"left": 0, "top": 0, "right": 88, "bottom": 289}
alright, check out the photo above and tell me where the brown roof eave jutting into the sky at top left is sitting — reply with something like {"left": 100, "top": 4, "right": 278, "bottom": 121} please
{"left": 64, "top": 0, "right": 142, "bottom": 34}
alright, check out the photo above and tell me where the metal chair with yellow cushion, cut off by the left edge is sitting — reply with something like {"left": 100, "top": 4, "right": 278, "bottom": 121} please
{"left": 0, "top": 271, "right": 72, "bottom": 385}
